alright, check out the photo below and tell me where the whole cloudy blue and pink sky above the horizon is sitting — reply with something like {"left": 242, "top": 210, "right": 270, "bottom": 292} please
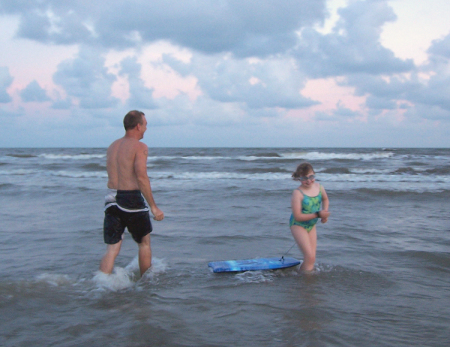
{"left": 0, "top": 0, "right": 450, "bottom": 148}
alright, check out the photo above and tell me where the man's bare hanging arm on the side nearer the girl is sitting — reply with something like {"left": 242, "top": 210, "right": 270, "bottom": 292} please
{"left": 134, "top": 142, "right": 164, "bottom": 221}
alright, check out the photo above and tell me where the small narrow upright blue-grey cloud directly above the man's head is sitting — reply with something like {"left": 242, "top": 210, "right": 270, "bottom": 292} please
{"left": 120, "top": 57, "right": 157, "bottom": 109}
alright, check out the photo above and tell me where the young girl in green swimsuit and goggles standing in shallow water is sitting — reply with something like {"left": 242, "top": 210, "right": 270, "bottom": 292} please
{"left": 289, "top": 163, "right": 330, "bottom": 272}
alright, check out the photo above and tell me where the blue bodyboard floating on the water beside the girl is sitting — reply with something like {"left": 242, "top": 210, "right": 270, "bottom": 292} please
{"left": 208, "top": 257, "right": 300, "bottom": 272}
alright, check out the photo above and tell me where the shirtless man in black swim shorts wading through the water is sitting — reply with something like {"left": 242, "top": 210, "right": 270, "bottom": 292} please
{"left": 100, "top": 111, "right": 164, "bottom": 276}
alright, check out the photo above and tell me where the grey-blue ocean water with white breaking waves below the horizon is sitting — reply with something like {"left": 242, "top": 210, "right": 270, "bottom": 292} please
{"left": 0, "top": 148, "right": 450, "bottom": 347}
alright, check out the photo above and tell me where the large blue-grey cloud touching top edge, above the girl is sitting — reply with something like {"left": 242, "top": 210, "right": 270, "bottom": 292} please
{"left": 294, "top": 0, "right": 414, "bottom": 78}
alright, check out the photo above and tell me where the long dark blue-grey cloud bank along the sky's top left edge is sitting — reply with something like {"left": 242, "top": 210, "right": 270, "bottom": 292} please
{"left": 0, "top": 0, "right": 326, "bottom": 57}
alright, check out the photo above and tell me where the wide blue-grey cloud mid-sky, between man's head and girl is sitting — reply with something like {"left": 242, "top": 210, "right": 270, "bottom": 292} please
{"left": 164, "top": 54, "right": 317, "bottom": 109}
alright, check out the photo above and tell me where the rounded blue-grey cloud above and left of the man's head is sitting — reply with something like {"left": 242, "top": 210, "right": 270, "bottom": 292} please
{"left": 53, "top": 47, "right": 118, "bottom": 109}
